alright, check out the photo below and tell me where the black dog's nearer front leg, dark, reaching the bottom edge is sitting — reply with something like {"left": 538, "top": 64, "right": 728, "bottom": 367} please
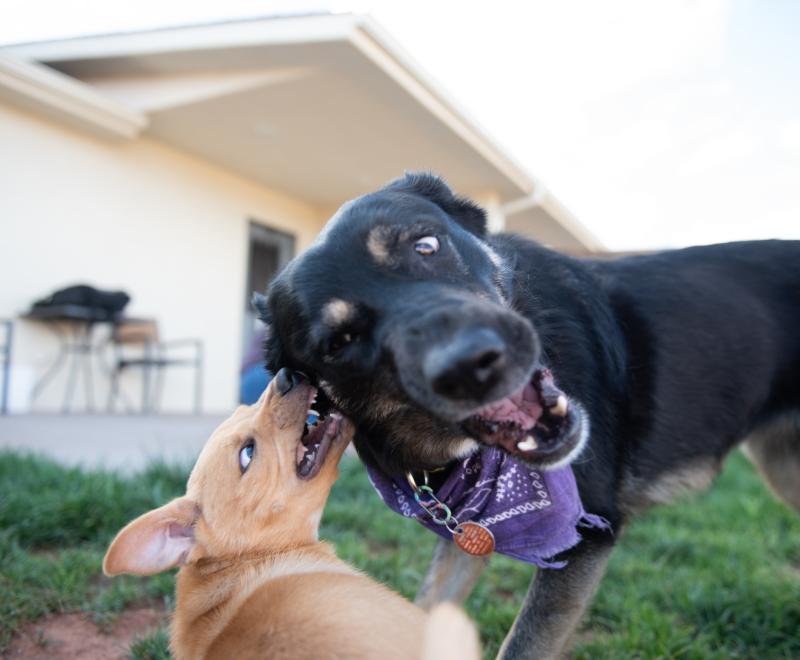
{"left": 498, "top": 539, "right": 614, "bottom": 660}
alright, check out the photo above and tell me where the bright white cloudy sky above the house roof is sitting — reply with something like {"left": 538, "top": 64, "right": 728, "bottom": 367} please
{"left": 0, "top": 0, "right": 800, "bottom": 250}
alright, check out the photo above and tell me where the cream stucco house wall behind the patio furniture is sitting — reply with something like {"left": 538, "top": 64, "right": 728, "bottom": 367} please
{"left": 0, "top": 105, "right": 323, "bottom": 412}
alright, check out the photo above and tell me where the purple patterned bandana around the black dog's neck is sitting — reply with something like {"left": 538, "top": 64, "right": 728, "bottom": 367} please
{"left": 367, "top": 447, "right": 610, "bottom": 568}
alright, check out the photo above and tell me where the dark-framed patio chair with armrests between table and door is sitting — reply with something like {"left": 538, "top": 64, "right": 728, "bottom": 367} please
{"left": 108, "top": 318, "right": 203, "bottom": 414}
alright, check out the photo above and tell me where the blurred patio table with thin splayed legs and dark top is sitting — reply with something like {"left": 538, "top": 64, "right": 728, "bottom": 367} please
{"left": 20, "top": 305, "right": 116, "bottom": 413}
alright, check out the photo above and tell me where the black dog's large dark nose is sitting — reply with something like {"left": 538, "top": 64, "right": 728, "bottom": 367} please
{"left": 422, "top": 328, "right": 507, "bottom": 399}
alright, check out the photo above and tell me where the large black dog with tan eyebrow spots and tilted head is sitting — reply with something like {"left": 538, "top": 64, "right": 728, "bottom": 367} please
{"left": 259, "top": 174, "right": 800, "bottom": 658}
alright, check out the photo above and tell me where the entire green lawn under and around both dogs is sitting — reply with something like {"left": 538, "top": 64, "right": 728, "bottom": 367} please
{"left": 0, "top": 446, "right": 800, "bottom": 659}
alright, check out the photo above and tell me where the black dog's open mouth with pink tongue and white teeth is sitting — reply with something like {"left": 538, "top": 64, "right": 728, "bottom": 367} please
{"left": 462, "top": 369, "right": 581, "bottom": 460}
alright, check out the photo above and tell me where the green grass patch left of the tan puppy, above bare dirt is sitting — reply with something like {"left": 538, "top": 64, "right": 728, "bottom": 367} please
{"left": 0, "top": 453, "right": 180, "bottom": 652}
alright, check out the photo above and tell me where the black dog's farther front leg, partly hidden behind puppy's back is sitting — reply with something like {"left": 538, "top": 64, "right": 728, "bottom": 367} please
{"left": 415, "top": 538, "right": 489, "bottom": 610}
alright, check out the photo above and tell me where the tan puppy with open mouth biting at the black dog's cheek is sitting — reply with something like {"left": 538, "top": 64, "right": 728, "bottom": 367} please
{"left": 103, "top": 370, "right": 479, "bottom": 660}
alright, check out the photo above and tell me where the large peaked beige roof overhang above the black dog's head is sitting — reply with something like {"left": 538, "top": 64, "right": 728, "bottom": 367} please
{"left": 5, "top": 14, "right": 595, "bottom": 248}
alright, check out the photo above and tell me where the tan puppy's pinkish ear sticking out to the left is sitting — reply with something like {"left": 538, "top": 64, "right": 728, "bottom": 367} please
{"left": 103, "top": 497, "right": 200, "bottom": 576}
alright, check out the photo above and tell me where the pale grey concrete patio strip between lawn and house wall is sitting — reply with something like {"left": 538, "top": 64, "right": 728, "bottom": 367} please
{"left": 0, "top": 415, "right": 225, "bottom": 472}
